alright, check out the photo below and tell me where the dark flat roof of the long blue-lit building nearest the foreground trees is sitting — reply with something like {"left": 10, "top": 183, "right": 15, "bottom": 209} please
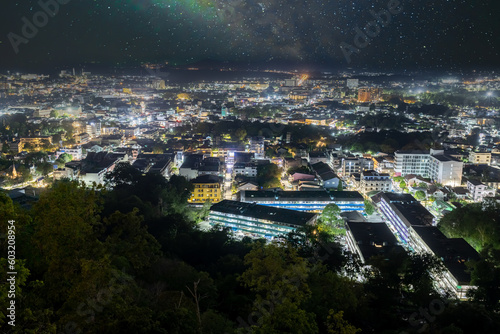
{"left": 210, "top": 200, "right": 316, "bottom": 227}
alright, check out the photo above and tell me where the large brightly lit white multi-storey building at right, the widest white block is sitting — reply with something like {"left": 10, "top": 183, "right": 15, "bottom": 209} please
{"left": 394, "top": 149, "right": 463, "bottom": 187}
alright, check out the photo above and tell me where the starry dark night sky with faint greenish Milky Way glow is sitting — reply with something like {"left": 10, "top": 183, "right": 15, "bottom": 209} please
{"left": 0, "top": 0, "right": 500, "bottom": 69}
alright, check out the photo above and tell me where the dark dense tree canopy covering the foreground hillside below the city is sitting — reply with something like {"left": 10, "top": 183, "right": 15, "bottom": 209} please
{"left": 0, "top": 176, "right": 500, "bottom": 334}
